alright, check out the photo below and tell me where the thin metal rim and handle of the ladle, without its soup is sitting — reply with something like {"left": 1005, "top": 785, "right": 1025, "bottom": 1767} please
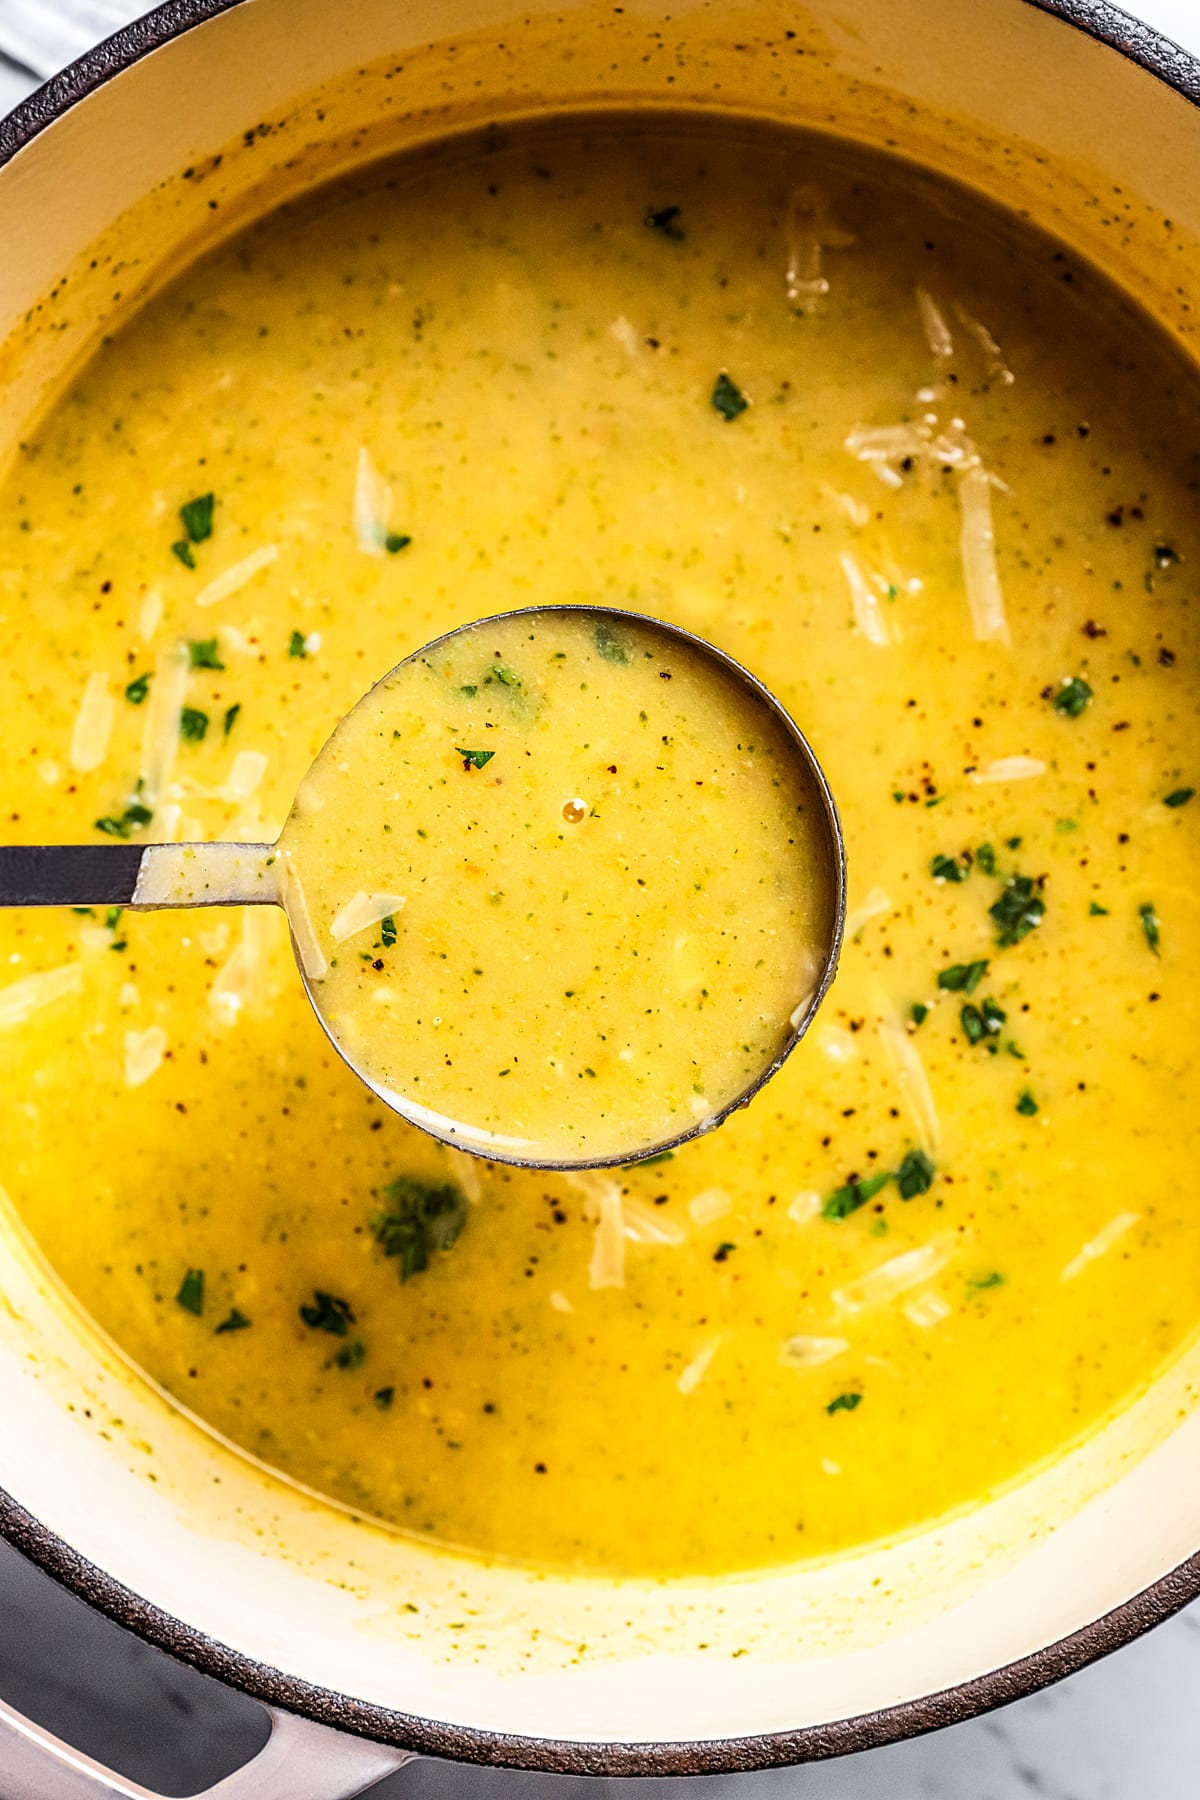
{"left": 0, "top": 605, "right": 846, "bottom": 1170}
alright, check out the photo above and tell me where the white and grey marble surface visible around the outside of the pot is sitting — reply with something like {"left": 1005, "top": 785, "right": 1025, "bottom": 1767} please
{"left": 0, "top": 0, "right": 1200, "bottom": 1800}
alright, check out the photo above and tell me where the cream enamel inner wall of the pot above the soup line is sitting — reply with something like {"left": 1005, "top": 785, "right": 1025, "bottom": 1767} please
{"left": 0, "top": 0, "right": 1200, "bottom": 1741}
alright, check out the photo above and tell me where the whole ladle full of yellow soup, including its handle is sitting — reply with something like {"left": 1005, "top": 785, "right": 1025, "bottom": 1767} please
{"left": 0, "top": 607, "right": 846, "bottom": 1168}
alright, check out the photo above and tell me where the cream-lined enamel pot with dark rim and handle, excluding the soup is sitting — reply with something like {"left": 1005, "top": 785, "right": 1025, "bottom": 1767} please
{"left": 0, "top": 0, "right": 1200, "bottom": 1800}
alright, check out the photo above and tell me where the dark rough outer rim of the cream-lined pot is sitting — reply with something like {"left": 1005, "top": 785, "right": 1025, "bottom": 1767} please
{"left": 0, "top": 0, "right": 1200, "bottom": 1777}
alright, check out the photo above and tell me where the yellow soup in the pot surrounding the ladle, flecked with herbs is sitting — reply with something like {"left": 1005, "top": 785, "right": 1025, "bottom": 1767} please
{"left": 0, "top": 121, "right": 1200, "bottom": 1573}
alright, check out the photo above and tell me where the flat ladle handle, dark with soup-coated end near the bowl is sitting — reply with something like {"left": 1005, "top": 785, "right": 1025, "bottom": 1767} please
{"left": 0, "top": 844, "right": 281, "bottom": 909}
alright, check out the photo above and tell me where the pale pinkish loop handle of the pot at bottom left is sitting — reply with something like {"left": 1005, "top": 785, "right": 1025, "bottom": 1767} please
{"left": 0, "top": 1701, "right": 412, "bottom": 1800}
